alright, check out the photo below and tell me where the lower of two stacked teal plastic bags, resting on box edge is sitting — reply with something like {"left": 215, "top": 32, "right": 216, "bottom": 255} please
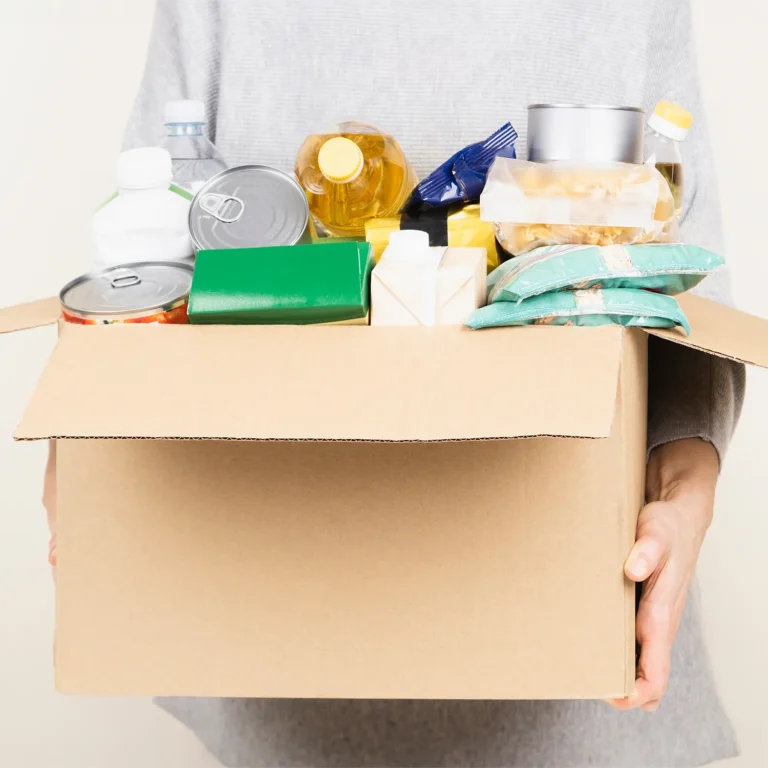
{"left": 466, "top": 288, "right": 691, "bottom": 333}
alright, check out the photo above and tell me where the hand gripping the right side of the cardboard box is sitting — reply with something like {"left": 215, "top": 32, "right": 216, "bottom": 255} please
{"left": 610, "top": 439, "right": 719, "bottom": 712}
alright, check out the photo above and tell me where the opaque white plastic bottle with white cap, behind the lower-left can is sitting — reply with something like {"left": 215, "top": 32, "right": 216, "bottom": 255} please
{"left": 91, "top": 147, "right": 194, "bottom": 269}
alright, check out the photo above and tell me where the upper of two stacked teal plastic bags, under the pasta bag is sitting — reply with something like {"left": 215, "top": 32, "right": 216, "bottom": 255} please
{"left": 488, "top": 243, "right": 723, "bottom": 303}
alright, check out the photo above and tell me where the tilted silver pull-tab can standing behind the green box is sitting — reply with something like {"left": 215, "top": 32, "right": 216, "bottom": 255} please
{"left": 189, "top": 165, "right": 309, "bottom": 251}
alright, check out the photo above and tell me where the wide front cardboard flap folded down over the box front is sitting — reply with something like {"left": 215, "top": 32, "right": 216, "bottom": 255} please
{"left": 16, "top": 325, "right": 623, "bottom": 442}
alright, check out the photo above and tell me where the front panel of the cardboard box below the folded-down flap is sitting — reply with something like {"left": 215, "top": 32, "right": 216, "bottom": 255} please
{"left": 56, "top": 426, "right": 642, "bottom": 699}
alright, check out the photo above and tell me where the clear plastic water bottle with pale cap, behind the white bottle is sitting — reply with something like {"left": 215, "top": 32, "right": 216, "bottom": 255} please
{"left": 164, "top": 101, "right": 228, "bottom": 194}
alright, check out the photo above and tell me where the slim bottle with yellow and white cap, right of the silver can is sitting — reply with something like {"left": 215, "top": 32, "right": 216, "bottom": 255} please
{"left": 645, "top": 101, "right": 693, "bottom": 219}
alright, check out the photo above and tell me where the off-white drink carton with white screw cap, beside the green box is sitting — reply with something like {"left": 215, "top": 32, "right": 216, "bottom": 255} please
{"left": 371, "top": 230, "right": 487, "bottom": 326}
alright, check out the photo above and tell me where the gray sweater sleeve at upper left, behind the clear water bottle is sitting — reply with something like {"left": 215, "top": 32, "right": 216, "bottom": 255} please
{"left": 124, "top": 0, "right": 219, "bottom": 149}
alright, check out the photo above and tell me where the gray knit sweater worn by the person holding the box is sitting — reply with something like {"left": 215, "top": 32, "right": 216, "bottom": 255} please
{"left": 126, "top": 0, "right": 744, "bottom": 768}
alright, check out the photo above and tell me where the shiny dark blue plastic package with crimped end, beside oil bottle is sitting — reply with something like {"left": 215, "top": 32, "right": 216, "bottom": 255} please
{"left": 402, "top": 123, "right": 517, "bottom": 215}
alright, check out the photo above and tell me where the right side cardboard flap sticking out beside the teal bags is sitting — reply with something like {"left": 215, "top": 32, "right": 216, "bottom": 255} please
{"left": 648, "top": 293, "right": 768, "bottom": 368}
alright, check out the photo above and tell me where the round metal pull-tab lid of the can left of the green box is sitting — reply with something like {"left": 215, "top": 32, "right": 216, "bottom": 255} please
{"left": 60, "top": 261, "right": 193, "bottom": 316}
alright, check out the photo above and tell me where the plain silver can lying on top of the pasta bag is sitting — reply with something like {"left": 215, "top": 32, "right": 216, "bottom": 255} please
{"left": 528, "top": 104, "right": 645, "bottom": 163}
